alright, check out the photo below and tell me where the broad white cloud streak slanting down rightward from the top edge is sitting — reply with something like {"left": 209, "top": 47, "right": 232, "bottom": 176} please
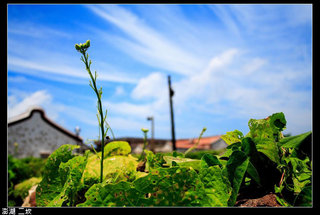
{"left": 88, "top": 5, "right": 204, "bottom": 75}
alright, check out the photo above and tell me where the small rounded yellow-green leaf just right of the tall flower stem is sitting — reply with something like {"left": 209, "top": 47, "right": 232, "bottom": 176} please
{"left": 104, "top": 141, "right": 131, "bottom": 158}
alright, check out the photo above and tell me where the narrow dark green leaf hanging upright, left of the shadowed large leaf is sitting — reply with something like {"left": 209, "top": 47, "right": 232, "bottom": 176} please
{"left": 225, "top": 151, "right": 249, "bottom": 206}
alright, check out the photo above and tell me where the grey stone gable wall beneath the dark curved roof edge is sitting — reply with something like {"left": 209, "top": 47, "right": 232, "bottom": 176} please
{"left": 8, "top": 112, "right": 77, "bottom": 158}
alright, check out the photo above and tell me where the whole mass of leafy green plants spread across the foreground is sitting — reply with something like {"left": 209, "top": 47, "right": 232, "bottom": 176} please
{"left": 37, "top": 113, "right": 312, "bottom": 207}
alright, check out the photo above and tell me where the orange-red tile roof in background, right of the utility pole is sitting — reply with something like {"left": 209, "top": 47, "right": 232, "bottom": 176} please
{"left": 176, "top": 135, "right": 221, "bottom": 149}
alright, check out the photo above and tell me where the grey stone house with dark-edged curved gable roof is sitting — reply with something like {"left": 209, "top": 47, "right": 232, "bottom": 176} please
{"left": 8, "top": 107, "right": 88, "bottom": 158}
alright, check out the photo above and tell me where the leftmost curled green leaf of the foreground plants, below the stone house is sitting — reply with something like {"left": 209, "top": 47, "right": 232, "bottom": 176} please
{"left": 36, "top": 144, "right": 80, "bottom": 206}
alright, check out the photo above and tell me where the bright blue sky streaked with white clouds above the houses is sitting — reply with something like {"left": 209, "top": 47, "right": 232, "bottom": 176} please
{"left": 7, "top": 4, "right": 312, "bottom": 144}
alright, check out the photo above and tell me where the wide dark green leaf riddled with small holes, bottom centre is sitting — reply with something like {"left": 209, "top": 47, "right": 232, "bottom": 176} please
{"left": 78, "top": 167, "right": 205, "bottom": 207}
